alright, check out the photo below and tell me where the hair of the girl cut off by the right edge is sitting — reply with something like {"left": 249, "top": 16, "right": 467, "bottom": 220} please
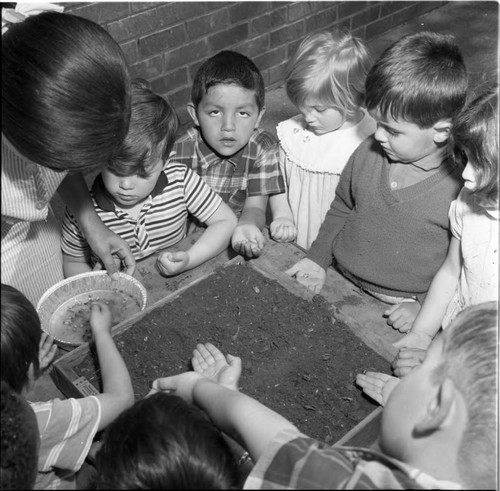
{"left": 452, "top": 86, "right": 499, "bottom": 208}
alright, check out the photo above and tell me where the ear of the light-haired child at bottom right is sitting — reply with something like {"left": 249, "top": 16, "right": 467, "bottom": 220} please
{"left": 414, "top": 378, "right": 457, "bottom": 436}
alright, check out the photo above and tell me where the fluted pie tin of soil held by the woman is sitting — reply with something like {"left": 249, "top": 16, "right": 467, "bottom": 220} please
{"left": 36, "top": 271, "right": 147, "bottom": 348}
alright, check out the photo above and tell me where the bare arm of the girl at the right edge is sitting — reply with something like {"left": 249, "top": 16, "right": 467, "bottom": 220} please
{"left": 393, "top": 237, "right": 462, "bottom": 349}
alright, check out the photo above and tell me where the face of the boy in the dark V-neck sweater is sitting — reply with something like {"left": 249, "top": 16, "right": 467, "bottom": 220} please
{"left": 370, "top": 110, "right": 448, "bottom": 170}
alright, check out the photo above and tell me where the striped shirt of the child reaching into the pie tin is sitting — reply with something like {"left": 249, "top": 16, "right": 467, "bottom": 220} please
{"left": 30, "top": 396, "right": 101, "bottom": 489}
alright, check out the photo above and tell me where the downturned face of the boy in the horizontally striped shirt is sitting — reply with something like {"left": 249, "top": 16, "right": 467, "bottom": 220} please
{"left": 101, "top": 159, "right": 163, "bottom": 209}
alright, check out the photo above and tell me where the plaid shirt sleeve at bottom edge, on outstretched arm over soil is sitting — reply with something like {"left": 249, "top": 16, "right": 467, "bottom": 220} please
{"left": 244, "top": 429, "right": 461, "bottom": 489}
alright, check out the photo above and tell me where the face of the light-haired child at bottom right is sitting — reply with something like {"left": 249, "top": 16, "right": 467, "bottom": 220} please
{"left": 380, "top": 338, "right": 443, "bottom": 461}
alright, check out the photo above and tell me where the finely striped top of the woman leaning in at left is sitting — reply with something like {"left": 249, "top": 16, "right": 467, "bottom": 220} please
{"left": 1, "top": 134, "right": 67, "bottom": 306}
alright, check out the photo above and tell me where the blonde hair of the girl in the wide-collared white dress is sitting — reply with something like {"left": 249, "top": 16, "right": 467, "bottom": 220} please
{"left": 285, "top": 30, "right": 370, "bottom": 117}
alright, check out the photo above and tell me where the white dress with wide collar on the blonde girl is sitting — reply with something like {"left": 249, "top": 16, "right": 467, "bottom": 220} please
{"left": 277, "top": 111, "right": 377, "bottom": 249}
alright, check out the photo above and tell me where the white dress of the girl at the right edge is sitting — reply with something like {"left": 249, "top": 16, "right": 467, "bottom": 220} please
{"left": 443, "top": 188, "right": 499, "bottom": 329}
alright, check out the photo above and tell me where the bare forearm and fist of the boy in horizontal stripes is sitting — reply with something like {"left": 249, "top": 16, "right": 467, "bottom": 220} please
{"left": 156, "top": 202, "right": 237, "bottom": 276}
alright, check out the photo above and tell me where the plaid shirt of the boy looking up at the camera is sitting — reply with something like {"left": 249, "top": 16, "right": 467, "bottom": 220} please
{"left": 170, "top": 127, "right": 286, "bottom": 216}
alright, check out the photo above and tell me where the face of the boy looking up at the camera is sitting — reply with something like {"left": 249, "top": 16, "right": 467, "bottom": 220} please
{"left": 188, "top": 84, "right": 264, "bottom": 157}
